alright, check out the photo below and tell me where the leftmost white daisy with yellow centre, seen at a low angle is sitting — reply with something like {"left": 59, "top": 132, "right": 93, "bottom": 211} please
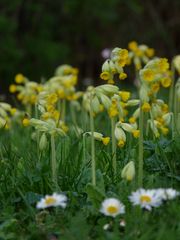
{"left": 36, "top": 193, "right": 67, "bottom": 208}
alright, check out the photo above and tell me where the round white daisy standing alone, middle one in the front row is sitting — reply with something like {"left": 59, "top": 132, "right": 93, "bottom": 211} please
{"left": 100, "top": 198, "right": 125, "bottom": 217}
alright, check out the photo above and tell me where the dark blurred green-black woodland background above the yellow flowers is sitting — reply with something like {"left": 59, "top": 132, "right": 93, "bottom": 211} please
{"left": 0, "top": 0, "right": 180, "bottom": 92}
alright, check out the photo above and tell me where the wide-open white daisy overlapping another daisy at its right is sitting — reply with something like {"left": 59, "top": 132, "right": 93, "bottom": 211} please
{"left": 129, "top": 188, "right": 162, "bottom": 211}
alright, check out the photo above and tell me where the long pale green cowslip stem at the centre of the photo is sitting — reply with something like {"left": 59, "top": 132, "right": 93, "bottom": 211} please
{"left": 90, "top": 94, "right": 96, "bottom": 186}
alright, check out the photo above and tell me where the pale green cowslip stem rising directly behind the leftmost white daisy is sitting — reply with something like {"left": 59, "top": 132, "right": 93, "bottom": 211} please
{"left": 51, "top": 134, "right": 57, "bottom": 189}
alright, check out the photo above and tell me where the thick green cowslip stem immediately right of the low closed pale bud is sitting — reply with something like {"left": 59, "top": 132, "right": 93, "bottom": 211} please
{"left": 138, "top": 104, "right": 144, "bottom": 187}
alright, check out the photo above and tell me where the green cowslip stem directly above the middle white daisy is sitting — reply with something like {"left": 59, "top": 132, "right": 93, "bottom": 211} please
{"left": 111, "top": 117, "right": 117, "bottom": 178}
